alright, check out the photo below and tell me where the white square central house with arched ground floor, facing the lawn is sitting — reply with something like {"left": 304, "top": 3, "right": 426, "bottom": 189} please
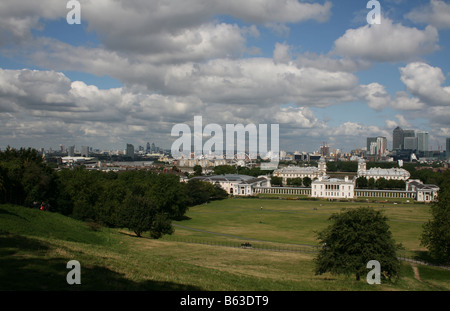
{"left": 311, "top": 176, "right": 355, "bottom": 199}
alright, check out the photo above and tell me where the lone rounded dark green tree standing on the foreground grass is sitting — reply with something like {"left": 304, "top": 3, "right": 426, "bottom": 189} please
{"left": 314, "top": 207, "right": 400, "bottom": 280}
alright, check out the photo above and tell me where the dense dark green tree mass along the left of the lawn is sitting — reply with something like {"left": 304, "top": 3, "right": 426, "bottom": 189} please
{"left": 0, "top": 148, "right": 228, "bottom": 238}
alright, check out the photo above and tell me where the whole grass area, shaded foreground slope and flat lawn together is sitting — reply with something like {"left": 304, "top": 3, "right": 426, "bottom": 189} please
{"left": 0, "top": 199, "right": 450, "bottom": 291}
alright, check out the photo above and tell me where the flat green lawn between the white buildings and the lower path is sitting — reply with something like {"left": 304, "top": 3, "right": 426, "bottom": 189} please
{"left": 169, "top": 199, "right": 430, "bottom": 253}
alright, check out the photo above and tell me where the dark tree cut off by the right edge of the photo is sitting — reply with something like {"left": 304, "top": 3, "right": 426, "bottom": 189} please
{"left": 421, "top": 171, "right": 450, "bottom": 264}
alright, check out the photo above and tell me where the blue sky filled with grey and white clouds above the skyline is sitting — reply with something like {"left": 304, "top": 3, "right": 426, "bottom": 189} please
{"left": 0, "top": 0, "right": 450, "bottom": 152}
